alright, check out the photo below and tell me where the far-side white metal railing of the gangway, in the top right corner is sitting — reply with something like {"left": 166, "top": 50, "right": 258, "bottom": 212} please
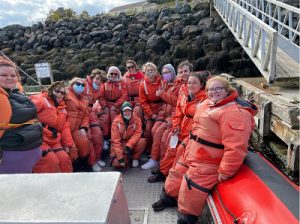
{"left": 234, "top": 0, "right": 300, "bottom": 47}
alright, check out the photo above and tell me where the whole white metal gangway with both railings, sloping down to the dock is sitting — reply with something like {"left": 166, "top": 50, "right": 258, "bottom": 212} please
{"left": 213, "top": 0, "right": 300, "bottom": 83}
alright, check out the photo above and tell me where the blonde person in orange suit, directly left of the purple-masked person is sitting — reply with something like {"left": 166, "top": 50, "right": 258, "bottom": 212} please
{"left": 139, "top": 62, "right": 164, "bottom": 152}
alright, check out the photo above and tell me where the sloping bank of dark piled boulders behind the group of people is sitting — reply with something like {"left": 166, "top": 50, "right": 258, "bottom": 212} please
{"left": 0, "top": 3, "right": 260, "bottom": 84}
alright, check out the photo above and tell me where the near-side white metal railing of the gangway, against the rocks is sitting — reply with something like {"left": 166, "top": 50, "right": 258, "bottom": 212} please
{"left": 213, "top": 0, "right": 278, "bottom": 83}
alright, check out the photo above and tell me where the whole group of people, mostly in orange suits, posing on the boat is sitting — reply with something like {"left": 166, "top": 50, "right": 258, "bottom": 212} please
{"left": 0, "top": 58, "right": 257, "bottom": 224}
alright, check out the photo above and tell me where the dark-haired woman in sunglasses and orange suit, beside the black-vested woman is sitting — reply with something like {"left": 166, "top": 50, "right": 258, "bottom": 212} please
{"left": 30, "top": 82, "right": 77, "bottom": 173}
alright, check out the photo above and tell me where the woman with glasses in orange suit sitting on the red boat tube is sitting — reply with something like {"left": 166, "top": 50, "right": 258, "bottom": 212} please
{"left": 152, "top": 77, "right": 258, "bottom": 224}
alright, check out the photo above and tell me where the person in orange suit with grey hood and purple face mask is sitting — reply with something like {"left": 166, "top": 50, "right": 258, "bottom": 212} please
{"left": 141, "top": 64, "right": 179, "bottom": 170}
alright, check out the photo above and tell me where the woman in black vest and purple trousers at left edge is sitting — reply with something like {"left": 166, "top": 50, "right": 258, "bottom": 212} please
{"left": 0, "top": 57, "right": 43, "bottom": 174}
